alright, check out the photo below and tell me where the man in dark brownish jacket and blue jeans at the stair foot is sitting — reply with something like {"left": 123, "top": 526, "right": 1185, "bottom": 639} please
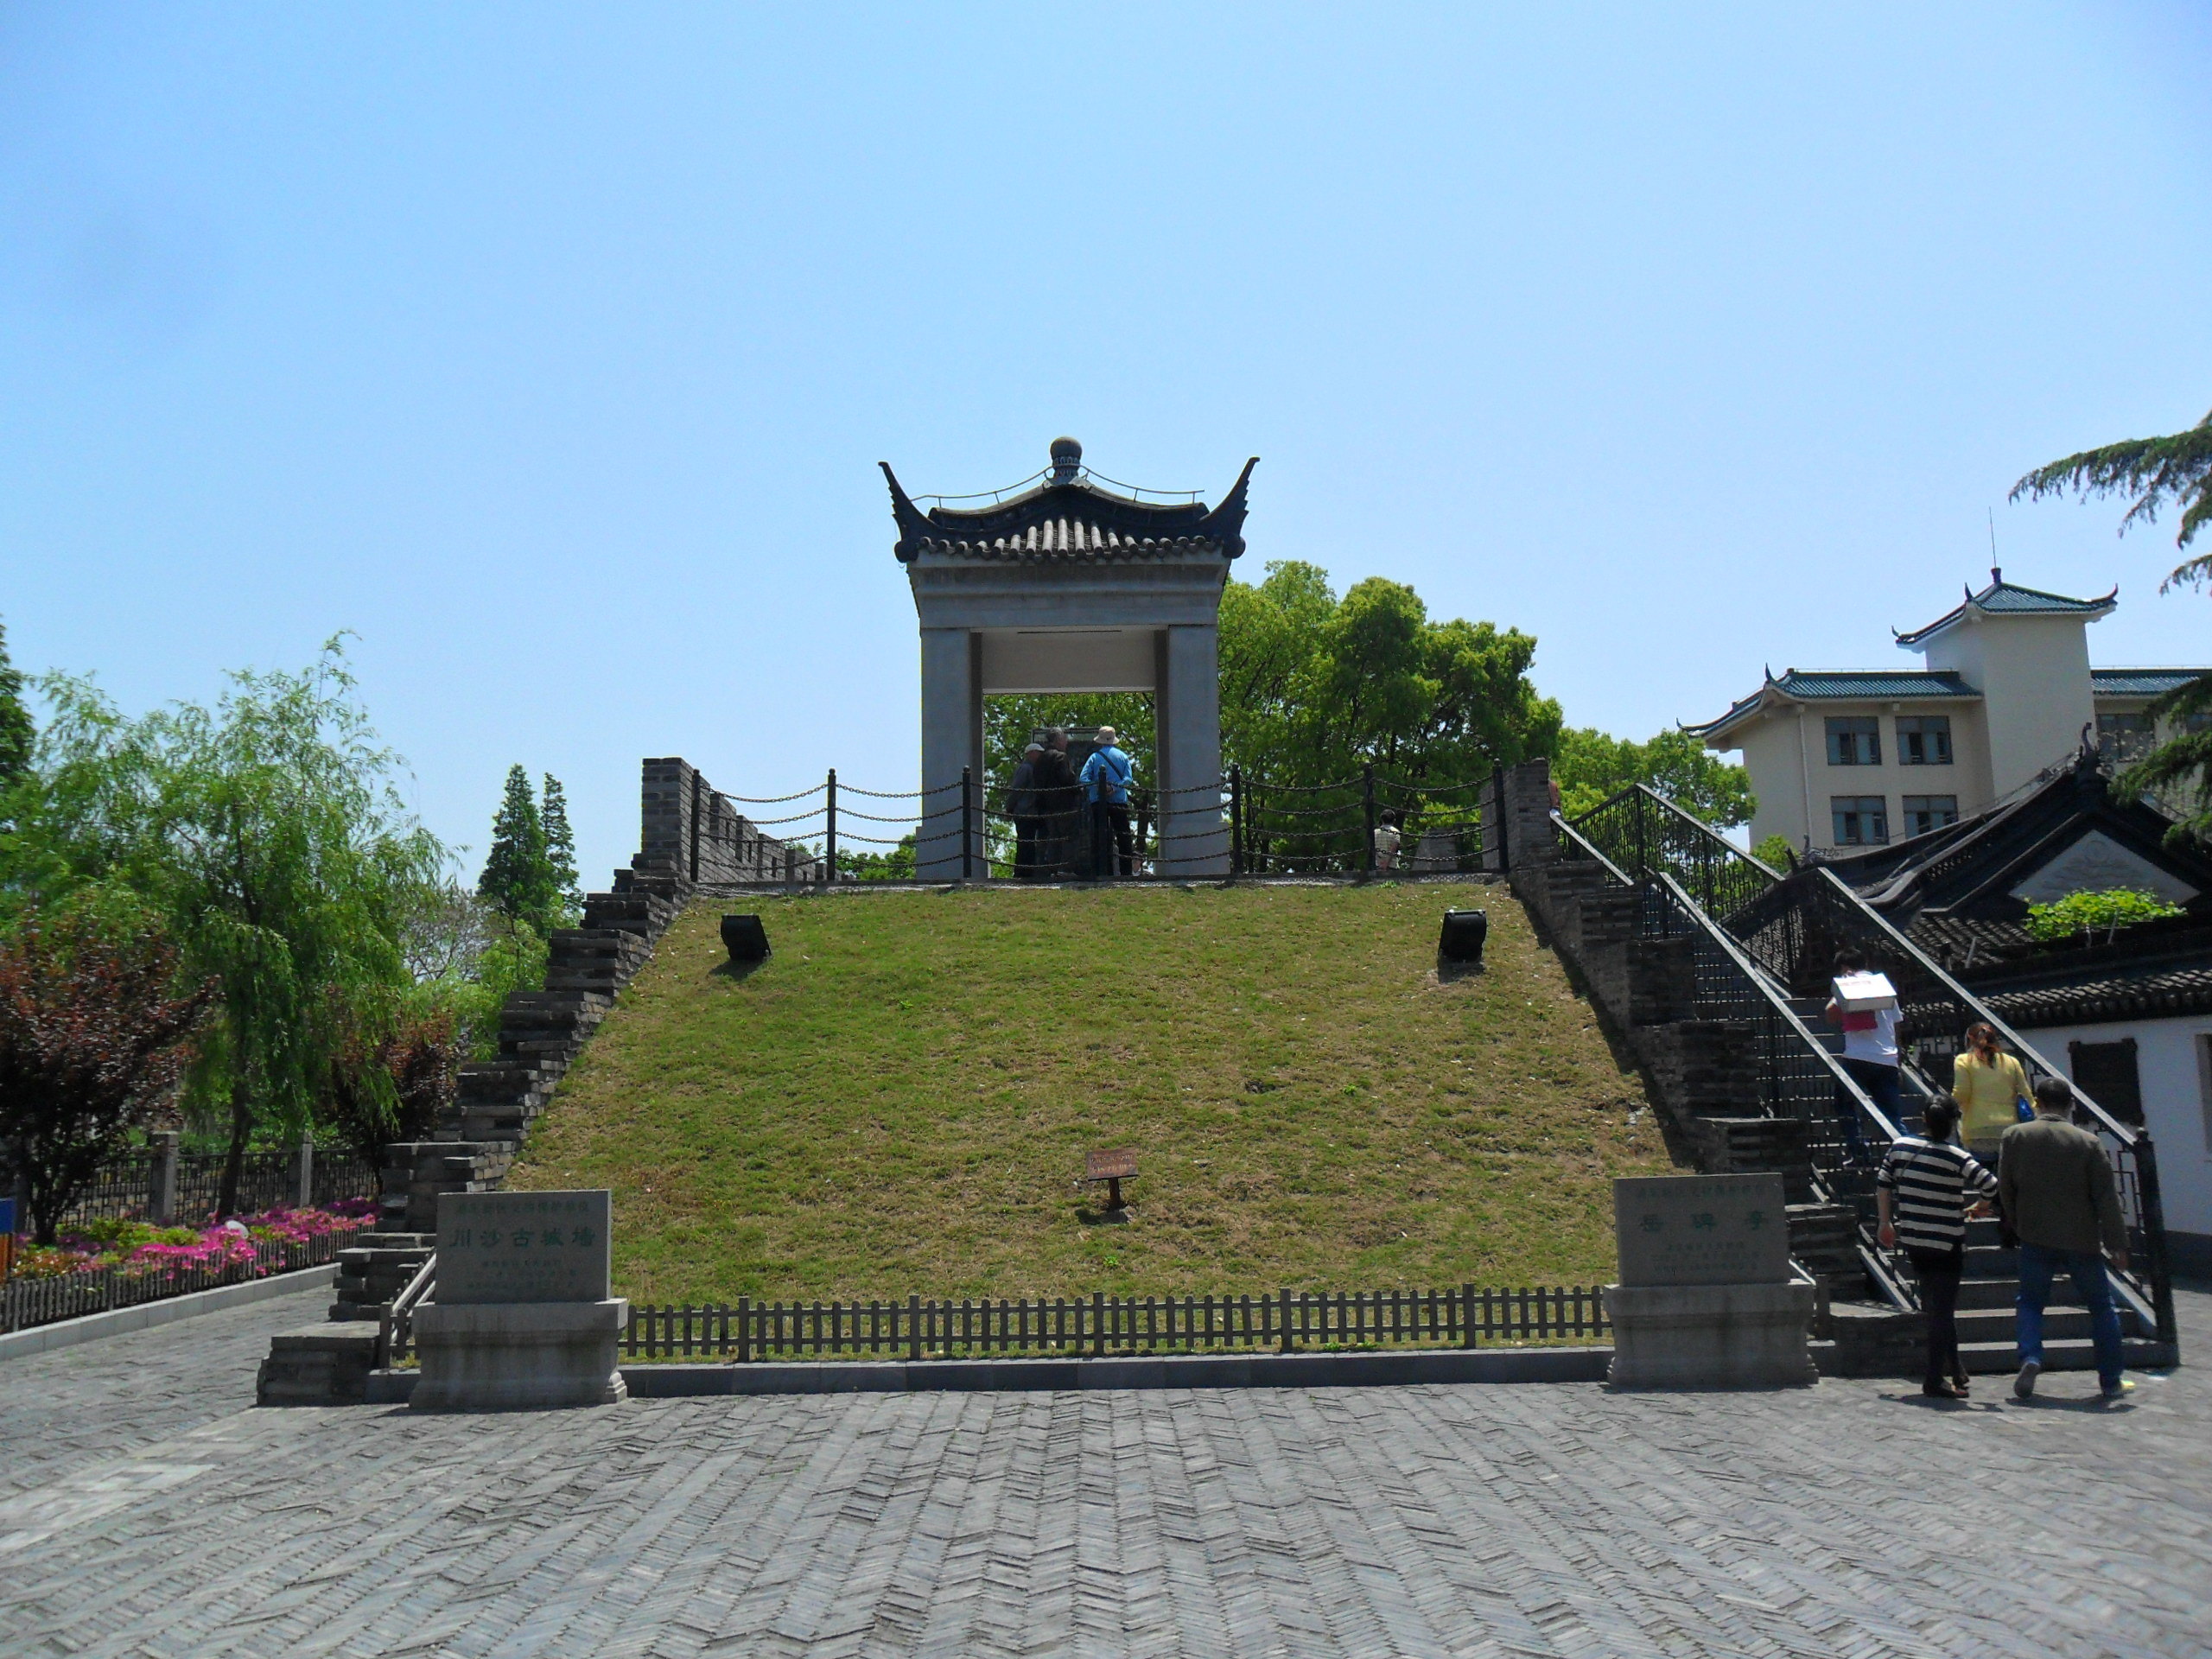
{"left": 1998, "top": 1077, "right": 2128, "bottom": 1400}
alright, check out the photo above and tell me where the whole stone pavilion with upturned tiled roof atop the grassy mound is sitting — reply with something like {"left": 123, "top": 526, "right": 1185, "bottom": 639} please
{"left": 882, "top": 438, "right": 1259, "bottom": 880}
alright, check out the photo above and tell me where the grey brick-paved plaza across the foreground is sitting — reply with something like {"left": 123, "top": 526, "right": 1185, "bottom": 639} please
{"left": 0, "top": 1294, "right": 2212, "bottom": 1659}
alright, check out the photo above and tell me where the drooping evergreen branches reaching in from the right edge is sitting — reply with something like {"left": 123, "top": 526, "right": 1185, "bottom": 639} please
{"left": 2011, "top": 414, "right": 2212, "bottom": 836}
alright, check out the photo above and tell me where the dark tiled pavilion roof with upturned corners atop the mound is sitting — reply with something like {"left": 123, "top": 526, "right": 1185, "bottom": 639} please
{"left": 882, "top": 438, "right": 1259, "bottom": 564}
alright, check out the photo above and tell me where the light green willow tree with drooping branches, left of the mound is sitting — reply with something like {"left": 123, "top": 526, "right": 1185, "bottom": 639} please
{"left": 11, "top": 639, "right": 445, "bottom": 1212}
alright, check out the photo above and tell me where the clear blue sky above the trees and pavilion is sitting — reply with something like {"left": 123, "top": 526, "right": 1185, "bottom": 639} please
{"left": 0, "top": 0, "right": 2212, "bottom": 885}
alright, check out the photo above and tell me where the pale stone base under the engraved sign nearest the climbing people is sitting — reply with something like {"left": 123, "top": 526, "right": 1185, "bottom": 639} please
{"left": 1606, "top": 1281, "right": 1821, "bottom": 1389}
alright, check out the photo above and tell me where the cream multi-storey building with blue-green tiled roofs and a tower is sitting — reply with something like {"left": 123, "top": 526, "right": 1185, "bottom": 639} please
{"left": 1688, "top": 570, "right": 2212, "bottom": 852}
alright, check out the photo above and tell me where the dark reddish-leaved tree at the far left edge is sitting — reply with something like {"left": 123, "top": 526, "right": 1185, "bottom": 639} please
{"left": 0, "top": 907, "right": 217, "bottom": 1245}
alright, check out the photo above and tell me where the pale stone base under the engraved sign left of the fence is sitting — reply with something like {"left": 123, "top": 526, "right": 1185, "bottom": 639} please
{"left": 407, "top": 1296, "right": 631, "bottom": 1411}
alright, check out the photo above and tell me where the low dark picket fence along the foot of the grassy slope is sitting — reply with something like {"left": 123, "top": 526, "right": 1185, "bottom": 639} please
{"left": 621, "top": 1285, "right": 1612, "bottom": 1363}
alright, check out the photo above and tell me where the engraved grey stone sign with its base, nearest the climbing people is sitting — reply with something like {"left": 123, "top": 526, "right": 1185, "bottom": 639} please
{"left": 1606, "top": 1174, "right": 1818, "bottom": 1389}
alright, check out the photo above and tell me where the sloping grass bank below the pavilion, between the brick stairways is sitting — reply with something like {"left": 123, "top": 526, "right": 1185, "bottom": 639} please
{"left": 513, "top": 885, "right": 1668, "bottom": 1303}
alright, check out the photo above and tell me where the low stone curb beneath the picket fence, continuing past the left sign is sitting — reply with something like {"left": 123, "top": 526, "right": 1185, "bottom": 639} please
{"left": 370, "top": 1347, "right": 1612, "bottom": 1405}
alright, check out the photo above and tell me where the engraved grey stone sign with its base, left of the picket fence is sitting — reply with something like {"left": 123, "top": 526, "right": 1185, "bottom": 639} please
{"left": 407, "top": 1188, "right": 631, "bottom": 1411}
